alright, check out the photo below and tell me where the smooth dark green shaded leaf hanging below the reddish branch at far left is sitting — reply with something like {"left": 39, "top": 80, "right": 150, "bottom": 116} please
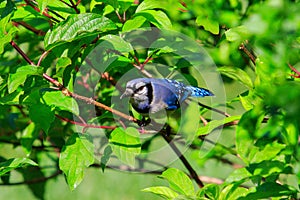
{"left": 29, "top": 103, "right": 55, "bottom": 133}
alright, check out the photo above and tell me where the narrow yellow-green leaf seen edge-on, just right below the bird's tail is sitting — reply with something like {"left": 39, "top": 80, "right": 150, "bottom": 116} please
{"left": 196, "top": 115, "right": 241, "bottom": 136}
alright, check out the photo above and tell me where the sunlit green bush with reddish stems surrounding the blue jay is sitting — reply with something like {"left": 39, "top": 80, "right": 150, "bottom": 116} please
{"left": 0, "top": 0, "right": 300, "bottom": 199}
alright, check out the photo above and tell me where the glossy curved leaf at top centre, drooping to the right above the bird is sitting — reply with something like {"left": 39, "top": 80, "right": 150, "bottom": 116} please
{"left": 135, "top": 10, "right": 172, "bottom": 29}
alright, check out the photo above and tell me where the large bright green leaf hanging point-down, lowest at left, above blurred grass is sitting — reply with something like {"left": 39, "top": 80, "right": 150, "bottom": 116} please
{"left": 59, "top": 133, "right": 94, "bottom": 190}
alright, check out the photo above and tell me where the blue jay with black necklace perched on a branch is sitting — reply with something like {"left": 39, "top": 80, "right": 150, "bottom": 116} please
{"left": 120, "top": 78, "right": 214, "bottom": 115}
